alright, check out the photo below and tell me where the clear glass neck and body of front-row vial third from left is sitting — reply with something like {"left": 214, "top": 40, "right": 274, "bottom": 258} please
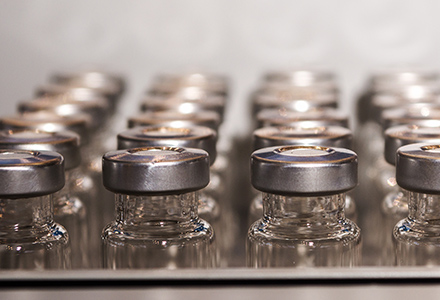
{"left": 247, "top": 194, "right": 361, "bottom": 268}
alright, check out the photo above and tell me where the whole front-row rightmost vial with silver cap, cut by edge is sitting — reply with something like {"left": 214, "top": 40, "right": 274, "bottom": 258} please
{"left": 393, "top": 143, "right": 440, "bottom": 266}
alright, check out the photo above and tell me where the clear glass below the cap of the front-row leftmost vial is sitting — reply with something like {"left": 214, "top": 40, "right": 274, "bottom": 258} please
{"left": 0, "top": 195, "right": 70, "bottom": 270}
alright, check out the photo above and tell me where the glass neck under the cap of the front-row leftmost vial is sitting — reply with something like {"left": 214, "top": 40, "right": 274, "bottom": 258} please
{"left": 0, "top": 195, "right": 53, "bottom": 232}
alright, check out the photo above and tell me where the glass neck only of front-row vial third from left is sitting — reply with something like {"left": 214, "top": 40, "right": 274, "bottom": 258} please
{"left": 263, "top": 193, "right": 345, "bottom": 226}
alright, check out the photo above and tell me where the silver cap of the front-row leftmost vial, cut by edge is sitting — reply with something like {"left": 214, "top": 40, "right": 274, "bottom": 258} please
{"left": 0, "top": 149, "right": 64, "bottom": 198}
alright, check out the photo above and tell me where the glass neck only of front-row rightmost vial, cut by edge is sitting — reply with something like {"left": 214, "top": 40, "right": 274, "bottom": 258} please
{"left": 408, "top": 192, "right": 440, "bottom": 225}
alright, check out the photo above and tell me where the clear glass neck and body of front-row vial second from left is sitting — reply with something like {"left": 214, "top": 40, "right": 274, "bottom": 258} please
{"left": 102, "top": 192, "right": 216, "bottom": 269}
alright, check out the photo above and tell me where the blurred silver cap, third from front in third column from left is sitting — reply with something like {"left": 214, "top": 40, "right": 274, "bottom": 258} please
{"left": 257, "top": 108, "right": 348, "bottom": 128}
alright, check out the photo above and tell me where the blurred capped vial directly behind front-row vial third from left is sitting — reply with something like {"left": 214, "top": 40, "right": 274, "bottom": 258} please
{"left": 249, "top": 123, "right": 357, "bottom": 223}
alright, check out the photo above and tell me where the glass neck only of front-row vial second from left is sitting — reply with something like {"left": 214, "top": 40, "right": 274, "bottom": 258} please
{"left": 116, "top": 192, "right": 199, "bottom": 226}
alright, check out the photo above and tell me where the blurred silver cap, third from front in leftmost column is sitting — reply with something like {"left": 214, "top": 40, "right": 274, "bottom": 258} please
{"left": 0, "top": 111, "right": 90, "bottom": 143}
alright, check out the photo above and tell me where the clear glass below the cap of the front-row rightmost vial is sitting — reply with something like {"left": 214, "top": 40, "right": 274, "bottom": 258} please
{"left": 393, "top": 192, "right": 440, "bottom": 266}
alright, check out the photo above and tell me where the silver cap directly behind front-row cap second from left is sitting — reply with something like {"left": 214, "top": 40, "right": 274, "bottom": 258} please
{"left": 118, "top": 126, "right": 217, "bottom": 164}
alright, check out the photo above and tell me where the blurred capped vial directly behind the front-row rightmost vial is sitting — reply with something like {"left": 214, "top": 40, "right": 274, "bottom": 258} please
{"left": 373, "top": 121, "right": 440, "bottom": 266}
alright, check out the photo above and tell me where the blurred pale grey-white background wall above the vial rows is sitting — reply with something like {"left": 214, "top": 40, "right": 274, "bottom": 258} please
{"left": 0, "top": 0, "right": 440, "bottom": 134}
